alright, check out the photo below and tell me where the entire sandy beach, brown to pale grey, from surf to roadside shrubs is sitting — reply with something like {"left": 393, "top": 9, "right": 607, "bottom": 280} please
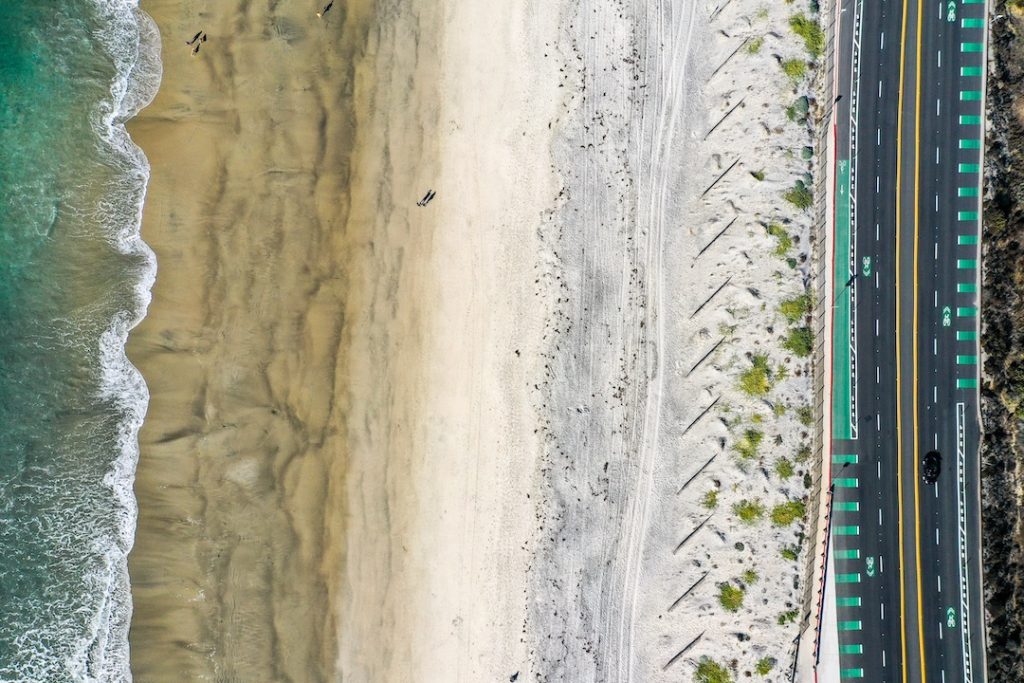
{"left": 129, "top": 0, "right": 823, "bottom": 681}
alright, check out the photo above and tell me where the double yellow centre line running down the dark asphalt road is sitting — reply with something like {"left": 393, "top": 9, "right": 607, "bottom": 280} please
{"left": 896, "top": 0, "right": 928, "bottom": 683}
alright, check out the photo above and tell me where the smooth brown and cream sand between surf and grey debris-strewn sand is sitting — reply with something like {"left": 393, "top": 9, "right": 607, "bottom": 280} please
{"left": 129, "top": 0, "right": 558, "bottom": 681}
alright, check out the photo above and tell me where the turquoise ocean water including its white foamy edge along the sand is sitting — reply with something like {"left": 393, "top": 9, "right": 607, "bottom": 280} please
{"left": 0, "top": 0, "right": 160, "bottom": 681}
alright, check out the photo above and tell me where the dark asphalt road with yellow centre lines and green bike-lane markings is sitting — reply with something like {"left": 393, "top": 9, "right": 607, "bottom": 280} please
{"left": 830, "top": 0, "right": 986, "bottom": 682}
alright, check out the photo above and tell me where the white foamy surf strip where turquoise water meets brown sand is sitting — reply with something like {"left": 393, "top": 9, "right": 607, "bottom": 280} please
{"left": 65, "top": 0, "right": 162, "bottom": 681}
